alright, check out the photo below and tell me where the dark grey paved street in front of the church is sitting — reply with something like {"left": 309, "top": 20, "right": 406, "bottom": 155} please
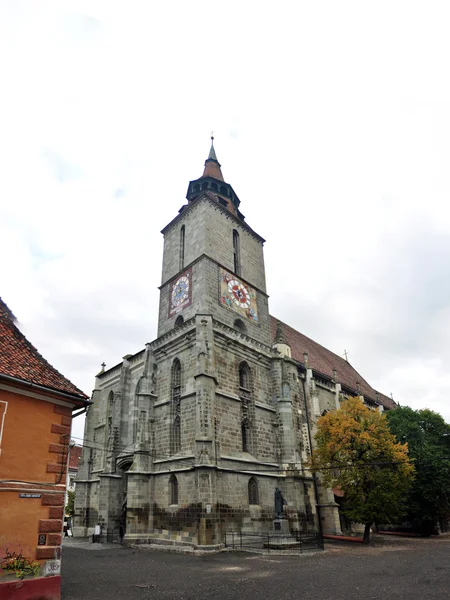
{"left": 62, "top": 537, "right": 450, "bottom": 600}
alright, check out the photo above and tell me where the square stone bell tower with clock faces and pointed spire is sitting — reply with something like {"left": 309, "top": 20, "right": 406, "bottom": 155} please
{"left": 158, "top": 138, "right": 271, "bottom": 345}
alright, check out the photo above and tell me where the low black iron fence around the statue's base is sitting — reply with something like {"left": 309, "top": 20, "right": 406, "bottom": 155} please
{"left": 223, "top": 531, "right": 324, "bottom": 554}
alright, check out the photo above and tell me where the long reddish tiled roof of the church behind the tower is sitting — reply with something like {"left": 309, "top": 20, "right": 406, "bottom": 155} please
{"left": 270, "top": 317, "right": 396, "bottom": 408}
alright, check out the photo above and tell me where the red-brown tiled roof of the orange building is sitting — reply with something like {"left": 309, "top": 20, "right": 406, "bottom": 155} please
{"left": 0, "top": 298, "right": 87, "bottom": 400}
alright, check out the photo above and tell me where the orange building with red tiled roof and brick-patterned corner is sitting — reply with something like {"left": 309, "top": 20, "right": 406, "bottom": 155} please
{"left": 0, "top": 298, "right": 88, "bottom": 600}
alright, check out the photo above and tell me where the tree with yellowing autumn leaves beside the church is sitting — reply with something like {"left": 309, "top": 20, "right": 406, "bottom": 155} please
{"left": 310, "top": 398, "right": 414, "bottom": 543}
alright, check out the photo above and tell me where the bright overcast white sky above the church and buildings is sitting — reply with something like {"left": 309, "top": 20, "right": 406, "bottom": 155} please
{"left": 0, "top": 0, "right": 450, "bottom": 438}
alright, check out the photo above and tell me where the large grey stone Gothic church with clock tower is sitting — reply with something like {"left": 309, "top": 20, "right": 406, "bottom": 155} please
{"left": 74, "top": 143, "right": 395, "bottom": 548}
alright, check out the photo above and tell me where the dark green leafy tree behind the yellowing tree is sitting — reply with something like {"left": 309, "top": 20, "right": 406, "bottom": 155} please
{"left": 387, "top": 406, "right": 450, "bottom": 535}
